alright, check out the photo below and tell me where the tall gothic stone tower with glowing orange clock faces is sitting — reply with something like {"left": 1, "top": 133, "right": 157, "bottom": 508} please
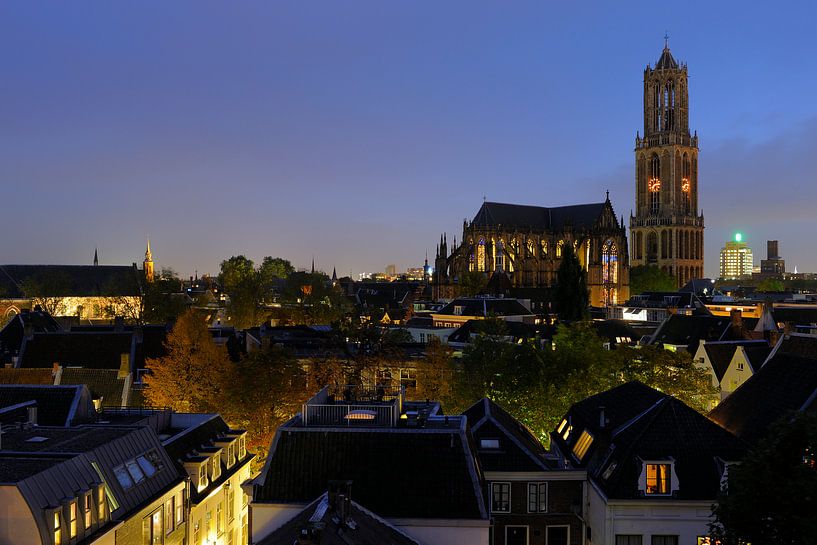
{"left": 630, "top": 40, "right": 704, "bottom": 287}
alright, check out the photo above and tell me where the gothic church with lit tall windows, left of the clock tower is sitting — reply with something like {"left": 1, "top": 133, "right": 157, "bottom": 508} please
{"left": 433, "top": 195, "right": 629, "bottom": 306}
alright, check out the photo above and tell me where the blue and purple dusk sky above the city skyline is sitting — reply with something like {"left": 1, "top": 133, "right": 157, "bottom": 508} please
{"left": 0, "top": 0, "right": 817, "bottom": 276}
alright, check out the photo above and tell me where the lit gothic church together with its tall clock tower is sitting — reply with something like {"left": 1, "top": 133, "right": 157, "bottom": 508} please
{"left": 433, "top": 44, "right": 704, "bottom": 307}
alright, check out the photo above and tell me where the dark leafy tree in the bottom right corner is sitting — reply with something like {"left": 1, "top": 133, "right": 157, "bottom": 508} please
{"left": 710, "top": 412, "right": 817, "bottom": 545}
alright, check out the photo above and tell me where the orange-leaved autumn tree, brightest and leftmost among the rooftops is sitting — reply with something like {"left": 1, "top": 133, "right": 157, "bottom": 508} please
{"left": 144, "top": 310, "right": 234, "bottom": 413}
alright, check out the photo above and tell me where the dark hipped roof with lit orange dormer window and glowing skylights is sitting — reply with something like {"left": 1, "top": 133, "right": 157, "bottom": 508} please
{"left": 551, "top": 382, "right": 745, "bottom": 500}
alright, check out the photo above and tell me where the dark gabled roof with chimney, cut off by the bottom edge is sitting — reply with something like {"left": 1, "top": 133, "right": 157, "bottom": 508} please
{"left": 258, "top": 492, "right": 419, "bottom": 545}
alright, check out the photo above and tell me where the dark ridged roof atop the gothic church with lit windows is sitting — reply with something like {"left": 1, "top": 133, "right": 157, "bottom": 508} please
{"left": 473, "top": 202, "right": 607, "bottom": 231}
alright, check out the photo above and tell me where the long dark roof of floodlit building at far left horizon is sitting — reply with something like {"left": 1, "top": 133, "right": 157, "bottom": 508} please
{"left": 0, "top": 265, "right": 141, "bottom": 297}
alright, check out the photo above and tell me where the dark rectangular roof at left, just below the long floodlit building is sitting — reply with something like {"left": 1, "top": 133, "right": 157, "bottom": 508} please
{"left": 18, "top": 331, "right": 135, "bottom": 369}
